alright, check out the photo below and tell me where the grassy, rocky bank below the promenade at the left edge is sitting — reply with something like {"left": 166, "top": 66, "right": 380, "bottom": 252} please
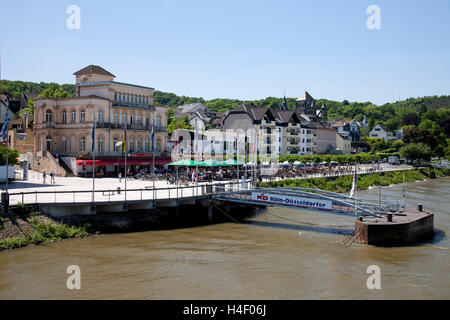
{"left": 0, "top": 207, "right": 92, "bottom": 251}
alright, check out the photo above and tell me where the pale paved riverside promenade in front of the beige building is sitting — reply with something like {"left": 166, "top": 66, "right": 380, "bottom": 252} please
{"left": 2, "top": 164, "right": 412, "bottom": 205}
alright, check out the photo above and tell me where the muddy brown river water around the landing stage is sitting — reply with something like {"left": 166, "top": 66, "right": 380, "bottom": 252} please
{"left": 0, "top": 179, "right": 450, "bottom": 299}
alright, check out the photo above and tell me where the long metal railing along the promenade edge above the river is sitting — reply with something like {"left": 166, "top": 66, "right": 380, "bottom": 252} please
{"left": 9, "top": 180, "right": 251, "bottom": 206}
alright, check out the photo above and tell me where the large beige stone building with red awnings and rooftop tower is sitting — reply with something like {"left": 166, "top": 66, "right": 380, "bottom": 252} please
{"left": 33, "top": 65, "right": 170, "bottom": 176}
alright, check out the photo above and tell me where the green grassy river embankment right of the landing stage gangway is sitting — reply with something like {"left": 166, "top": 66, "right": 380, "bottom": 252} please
{"left": 258, "top": 168, "right": 450, "bottom": 193}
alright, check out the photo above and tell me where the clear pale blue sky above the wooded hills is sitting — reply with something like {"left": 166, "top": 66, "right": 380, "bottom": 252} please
{"left": 0, "top": 0, "right": 450, "bottom": 104}
